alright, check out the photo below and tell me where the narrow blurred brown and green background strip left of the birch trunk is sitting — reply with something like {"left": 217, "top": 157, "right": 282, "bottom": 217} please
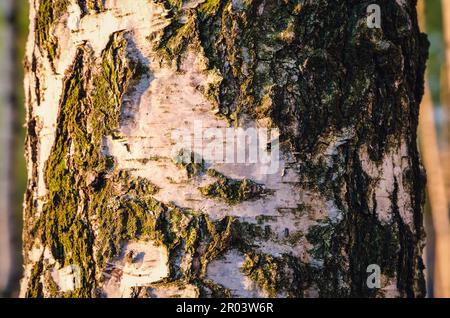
{"left": 0, "top": 0, "right": 28, "bottom": 297}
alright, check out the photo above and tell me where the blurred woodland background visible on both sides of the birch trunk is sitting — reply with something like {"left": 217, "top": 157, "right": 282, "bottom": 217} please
{"left": 0, "top": 0, "right": 450, "bottom": 297}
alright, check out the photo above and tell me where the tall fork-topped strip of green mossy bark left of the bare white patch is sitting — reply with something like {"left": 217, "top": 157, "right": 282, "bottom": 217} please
{"left": 39, "top": 33, "right": 150, "bottom": 297}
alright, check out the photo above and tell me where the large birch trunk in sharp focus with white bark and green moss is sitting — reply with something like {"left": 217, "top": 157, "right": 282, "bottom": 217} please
{"left": 22, "top": 0, "right": 428, "bottom": 297}
